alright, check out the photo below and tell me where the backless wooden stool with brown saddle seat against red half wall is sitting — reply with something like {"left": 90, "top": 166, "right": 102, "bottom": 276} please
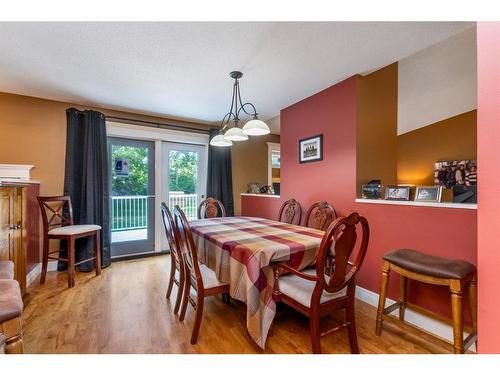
{"left": 375, "top": 249, "right": 477, "bottom": 354}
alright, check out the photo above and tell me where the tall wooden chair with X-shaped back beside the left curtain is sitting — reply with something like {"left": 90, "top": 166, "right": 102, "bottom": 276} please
{"left": 37, "top": 196, "right": 101, "bottom": 288}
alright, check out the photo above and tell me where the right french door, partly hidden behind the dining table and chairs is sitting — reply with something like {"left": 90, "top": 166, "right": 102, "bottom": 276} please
{"left": 162, "top": 142, "right": 207, "bottom": 220}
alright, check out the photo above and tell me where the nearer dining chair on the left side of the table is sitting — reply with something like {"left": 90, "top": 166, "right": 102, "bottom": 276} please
{"left": 174, "top": 206, "right": 229, "bottom": 345}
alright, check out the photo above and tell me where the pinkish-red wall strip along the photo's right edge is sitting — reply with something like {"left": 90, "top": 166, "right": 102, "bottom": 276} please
{"left": 477, "top": 22, "right": 500, "bottom": 353}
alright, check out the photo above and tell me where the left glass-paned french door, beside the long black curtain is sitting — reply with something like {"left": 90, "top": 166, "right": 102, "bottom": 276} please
{"left": 108, "top": 137, "right": 155, "bottom": 257}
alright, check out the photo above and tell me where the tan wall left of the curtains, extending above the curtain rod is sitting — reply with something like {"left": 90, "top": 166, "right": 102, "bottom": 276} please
{"left": 0, "top": 93, "right": 211, "bottom": 195}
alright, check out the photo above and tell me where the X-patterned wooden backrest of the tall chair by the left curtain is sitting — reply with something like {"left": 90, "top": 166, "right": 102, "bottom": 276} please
{"left": 36, "top": 195, "right": 73, "bottom": 233}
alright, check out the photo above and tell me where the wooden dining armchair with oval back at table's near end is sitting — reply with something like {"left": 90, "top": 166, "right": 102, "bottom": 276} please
{"left": 273, "top": 213, "right": 370, "bottom": 353}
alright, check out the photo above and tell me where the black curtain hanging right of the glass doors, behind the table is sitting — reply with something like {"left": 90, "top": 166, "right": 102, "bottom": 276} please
{"left": 207, "top": 129, "right": 234, "bottom": 216}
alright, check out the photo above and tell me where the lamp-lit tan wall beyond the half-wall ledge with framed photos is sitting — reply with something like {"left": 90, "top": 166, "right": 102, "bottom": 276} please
{"left": 398, "top": 110, "right": 477, "bottom": 185}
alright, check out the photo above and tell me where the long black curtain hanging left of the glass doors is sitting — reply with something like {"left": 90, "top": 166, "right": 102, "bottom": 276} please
{"left": 58, "top": 108, "right": 111, "bottom": 272}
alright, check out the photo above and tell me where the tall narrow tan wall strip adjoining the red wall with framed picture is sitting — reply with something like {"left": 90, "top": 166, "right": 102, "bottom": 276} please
{"left": 356, "top": 63, "right": 398, "bottom": 196}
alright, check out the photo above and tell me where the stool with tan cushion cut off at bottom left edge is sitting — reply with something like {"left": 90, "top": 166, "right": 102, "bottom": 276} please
{"left": 0, "top": 280, "right": 24, "bottom": 354}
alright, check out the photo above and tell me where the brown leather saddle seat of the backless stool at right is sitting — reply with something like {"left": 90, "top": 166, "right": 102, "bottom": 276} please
{"left": 383, "top": 249, "right": 476, "bottom": 280}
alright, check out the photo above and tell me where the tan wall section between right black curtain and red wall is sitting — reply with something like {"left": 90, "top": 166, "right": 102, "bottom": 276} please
{"left": 231, "top": 134, "right": 280, "bottom": 215}
